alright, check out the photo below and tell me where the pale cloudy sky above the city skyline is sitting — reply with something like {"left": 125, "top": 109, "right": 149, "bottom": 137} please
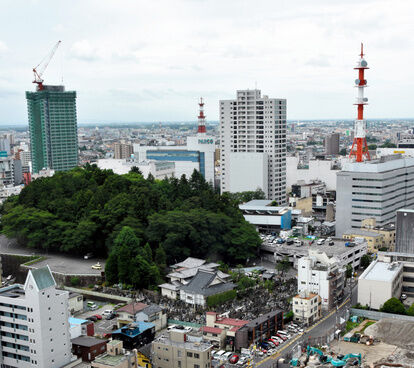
{"left": 0, "top": 0, "right": 414, "bottom": 125}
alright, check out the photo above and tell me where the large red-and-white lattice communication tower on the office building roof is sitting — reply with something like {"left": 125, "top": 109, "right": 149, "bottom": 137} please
{"left": 349, "top": 43, "right": 371, "bottom": 162}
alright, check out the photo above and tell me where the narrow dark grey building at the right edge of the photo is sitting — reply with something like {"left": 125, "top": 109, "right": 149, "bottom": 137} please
{"left": 395, "top": 208, "right": 414, "bottom": 255}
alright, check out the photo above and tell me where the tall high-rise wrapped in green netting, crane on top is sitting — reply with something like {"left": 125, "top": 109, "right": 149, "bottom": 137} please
{"left": 26, "top": 85, "right": 78, "bottom": 173}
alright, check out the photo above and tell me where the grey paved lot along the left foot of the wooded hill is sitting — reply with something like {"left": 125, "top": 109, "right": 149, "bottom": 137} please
{"left": 0, "top": 235, "right": 105, "bottom": 275}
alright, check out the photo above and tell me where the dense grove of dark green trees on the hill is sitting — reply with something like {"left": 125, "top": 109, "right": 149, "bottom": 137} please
{"left": 1, "top": 165, "right": 261, "bottom": 268}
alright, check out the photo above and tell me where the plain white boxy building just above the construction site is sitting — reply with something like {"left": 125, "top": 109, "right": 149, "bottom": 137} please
{"left": 358, "top": 260, "right": 403, "bottom": 309}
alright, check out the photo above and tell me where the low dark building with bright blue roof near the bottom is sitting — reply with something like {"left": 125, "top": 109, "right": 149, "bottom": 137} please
{"left": 112, "top": 322, "right": 155, "bottom": 350}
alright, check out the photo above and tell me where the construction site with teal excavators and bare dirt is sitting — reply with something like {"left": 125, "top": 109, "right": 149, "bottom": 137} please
{"left": 290, "top": 318, "right": 414, "bottom": 368}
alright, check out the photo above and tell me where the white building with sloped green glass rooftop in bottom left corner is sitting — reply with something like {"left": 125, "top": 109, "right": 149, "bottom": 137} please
{"left": 0, "top": 267, "right": 72, "bottom": 368}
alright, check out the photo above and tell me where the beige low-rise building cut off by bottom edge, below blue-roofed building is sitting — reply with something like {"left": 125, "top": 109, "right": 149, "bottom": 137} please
{"left": 91, "top": 340, "right": 139, "bottom": 368}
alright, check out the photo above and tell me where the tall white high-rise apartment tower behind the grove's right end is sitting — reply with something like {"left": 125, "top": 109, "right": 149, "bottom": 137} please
{"left": 220, "top": 89, "right": 286, "bottom": 205}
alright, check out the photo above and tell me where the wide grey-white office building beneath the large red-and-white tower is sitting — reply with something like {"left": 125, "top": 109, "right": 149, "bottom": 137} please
{"left": 336, "top": 155, "right": 414, "bottom": 237}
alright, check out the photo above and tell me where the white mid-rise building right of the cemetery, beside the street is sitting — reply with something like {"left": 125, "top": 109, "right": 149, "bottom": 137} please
{"left": 298, "top": 249, "right": 345, "bottom": 309}
